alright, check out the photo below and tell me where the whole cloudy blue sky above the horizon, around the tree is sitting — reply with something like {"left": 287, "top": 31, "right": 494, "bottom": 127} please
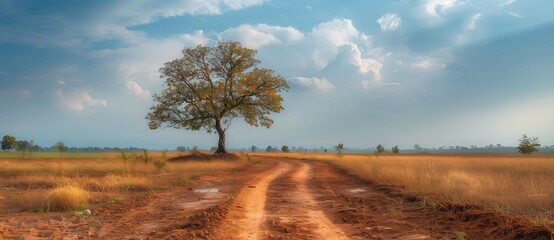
{"left": 0, "top": 0, "right": 554, "bottom": 149}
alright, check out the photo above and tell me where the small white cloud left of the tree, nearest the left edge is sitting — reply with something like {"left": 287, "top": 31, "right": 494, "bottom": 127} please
{"left": 54, "top": 89, "right": 108, "bottom": 111}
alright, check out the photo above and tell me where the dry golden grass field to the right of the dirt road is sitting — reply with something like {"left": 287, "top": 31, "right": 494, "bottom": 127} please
{"left": 254, "top": 153, "right": 554, "bottom": 222}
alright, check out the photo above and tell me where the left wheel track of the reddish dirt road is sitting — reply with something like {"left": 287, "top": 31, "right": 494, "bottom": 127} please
{"left": 215, "top": 158, "right": 291, "bottom": 239}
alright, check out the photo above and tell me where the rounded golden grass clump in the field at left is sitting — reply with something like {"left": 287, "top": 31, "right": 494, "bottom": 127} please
{"left": 47, "top": 186, "right": 90, "bottom": 211}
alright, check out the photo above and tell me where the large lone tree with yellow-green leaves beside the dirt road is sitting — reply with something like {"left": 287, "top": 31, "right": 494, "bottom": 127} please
{"left": 146, "top": 42, "right": 289, "bottom": 153}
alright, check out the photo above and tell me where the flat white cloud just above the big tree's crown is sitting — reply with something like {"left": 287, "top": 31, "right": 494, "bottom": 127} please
{"left": 218, "top": 24, "right": 304, "bottom": 49}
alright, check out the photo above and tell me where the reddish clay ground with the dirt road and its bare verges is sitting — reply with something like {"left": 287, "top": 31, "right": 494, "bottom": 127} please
{"left": 0, "top": 157, "right": 554, "bottom": 240}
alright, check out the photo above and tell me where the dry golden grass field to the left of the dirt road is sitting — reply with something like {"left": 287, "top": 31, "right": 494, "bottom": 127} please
{"left": 0, "top": 152, "right": 249, "bottom": 213}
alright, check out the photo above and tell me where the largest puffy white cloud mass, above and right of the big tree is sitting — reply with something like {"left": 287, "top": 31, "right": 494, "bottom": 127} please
{"left": 212, "top": 18, "right": 383, "bottom": 91}
